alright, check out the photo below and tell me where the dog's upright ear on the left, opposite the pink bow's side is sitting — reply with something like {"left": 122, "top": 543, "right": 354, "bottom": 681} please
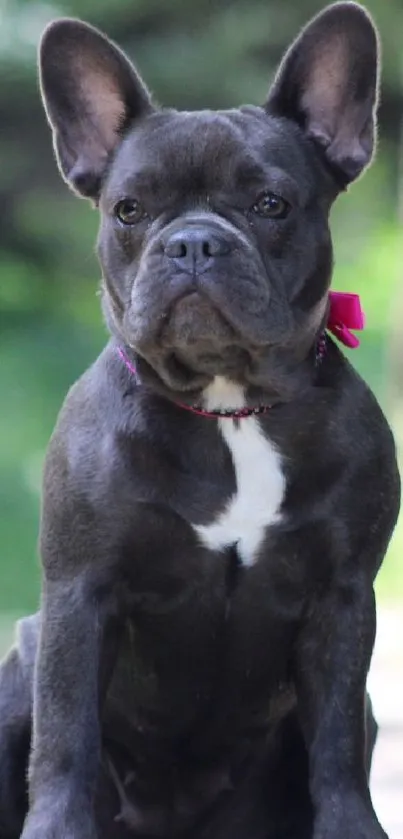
{"left": 39, "top": 18, "right": 153, "bottom": 201}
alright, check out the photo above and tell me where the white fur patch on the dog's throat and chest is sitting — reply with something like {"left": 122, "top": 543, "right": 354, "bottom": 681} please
{"left": 194, "top": 377, "right": 286, "bottom": 565}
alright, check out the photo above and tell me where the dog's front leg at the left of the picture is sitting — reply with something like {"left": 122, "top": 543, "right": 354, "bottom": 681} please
{"left": 22, "top": 568, "right": 109, "bottom": 839}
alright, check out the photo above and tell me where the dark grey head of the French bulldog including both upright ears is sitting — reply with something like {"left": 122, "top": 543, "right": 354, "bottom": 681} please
{"left": 40, "top": 3, "right": 377, "bottom": 394}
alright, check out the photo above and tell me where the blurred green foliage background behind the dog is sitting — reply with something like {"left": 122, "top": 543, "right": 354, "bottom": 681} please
{"left": 0, "top": 0, "right": 403, "bottom": 615}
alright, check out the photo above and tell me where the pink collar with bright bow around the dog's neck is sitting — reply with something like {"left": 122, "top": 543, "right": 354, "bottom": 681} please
{"left": 118, "top": 291, "right": 365, "bottom": 419}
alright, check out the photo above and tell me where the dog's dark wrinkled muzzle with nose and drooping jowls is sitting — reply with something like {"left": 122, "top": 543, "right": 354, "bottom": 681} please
{"left": 125, "top": 212, "right": 290, "bottom": 368}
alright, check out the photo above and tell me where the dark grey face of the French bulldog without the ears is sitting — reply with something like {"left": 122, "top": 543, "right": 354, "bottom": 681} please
{"left": 99, "top": 108, "right": 334, "bottom": 387}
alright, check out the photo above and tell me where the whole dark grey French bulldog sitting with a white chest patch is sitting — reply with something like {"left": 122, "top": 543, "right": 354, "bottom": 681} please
{"left": 0, "top": 2, "right": 400, "bottom": 839}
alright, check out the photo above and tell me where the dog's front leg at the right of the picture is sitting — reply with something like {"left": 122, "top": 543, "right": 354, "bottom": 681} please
{"left": 296, "top": 574, "right": 386, "bottom": 839}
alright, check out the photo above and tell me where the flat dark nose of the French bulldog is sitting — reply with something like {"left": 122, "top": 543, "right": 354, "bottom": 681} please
{"left": 164, "top": 227, "right": 231, "bottom": 274}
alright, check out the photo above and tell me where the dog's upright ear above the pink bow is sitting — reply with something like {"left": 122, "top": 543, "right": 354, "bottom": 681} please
{"left": 266, "top": 2, "right": 378, "bottom": 186}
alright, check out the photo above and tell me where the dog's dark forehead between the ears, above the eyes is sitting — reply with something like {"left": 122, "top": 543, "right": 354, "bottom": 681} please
{"left": 103, "top": 108, "right": 315, "bottom": 204}
